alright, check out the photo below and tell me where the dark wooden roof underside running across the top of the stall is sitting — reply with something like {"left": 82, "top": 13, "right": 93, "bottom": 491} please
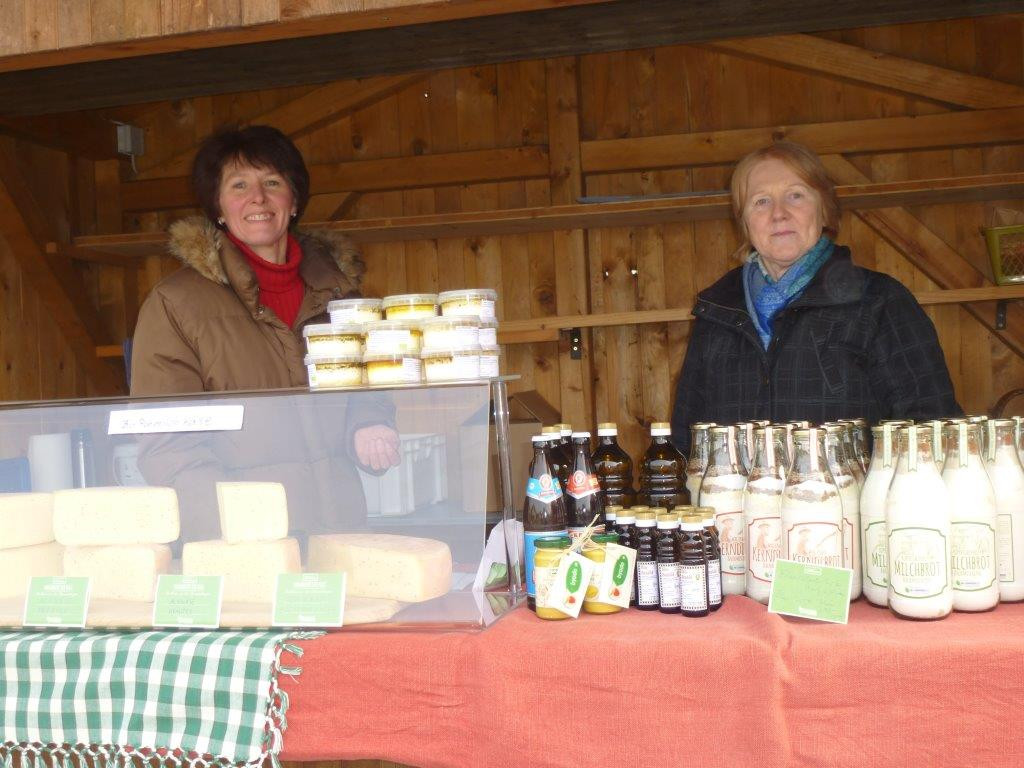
{"left": 0, "top": 0, "right": 1021, "bottom": 117}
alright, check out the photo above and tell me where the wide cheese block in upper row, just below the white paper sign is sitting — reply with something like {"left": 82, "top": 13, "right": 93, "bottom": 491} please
{"left": 53, "top": 487, "right": 179, "bottom": 547}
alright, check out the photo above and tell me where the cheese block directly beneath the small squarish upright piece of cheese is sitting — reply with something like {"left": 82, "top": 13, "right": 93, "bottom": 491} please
{"left": 181, "top": 539, "right": 302, "bottom": 603}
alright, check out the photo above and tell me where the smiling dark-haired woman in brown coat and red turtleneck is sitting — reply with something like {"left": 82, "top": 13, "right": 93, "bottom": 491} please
{"left": 131, "top": 125, "right": 399, "bottom": 539}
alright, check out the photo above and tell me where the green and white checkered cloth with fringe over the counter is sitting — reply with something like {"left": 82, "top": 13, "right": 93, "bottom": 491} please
{"left": 0, "top": 631, "right": 322, "bottom": 768}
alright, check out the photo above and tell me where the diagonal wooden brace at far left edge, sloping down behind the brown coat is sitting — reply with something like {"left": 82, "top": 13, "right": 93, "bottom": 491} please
{"left": 0, "top": 141, "right": 124, "bottom": 394}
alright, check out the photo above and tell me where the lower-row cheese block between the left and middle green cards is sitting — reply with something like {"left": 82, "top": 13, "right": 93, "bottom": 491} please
{"left": 63, "top": 544, "right": 171, "bottom": 602}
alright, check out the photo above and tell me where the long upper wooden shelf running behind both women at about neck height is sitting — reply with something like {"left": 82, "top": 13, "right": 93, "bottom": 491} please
{"left": 75, "top": 173, "right": 1024, "bottom": 257}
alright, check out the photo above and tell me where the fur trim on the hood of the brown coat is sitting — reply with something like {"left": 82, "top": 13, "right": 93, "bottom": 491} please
{"left": 167, "top": 216, "right": 367, "bottom": 292}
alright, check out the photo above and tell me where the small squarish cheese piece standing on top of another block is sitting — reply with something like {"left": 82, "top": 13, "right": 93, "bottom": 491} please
{"left": 217, "top": 482, "right": 288, "bottom": 544}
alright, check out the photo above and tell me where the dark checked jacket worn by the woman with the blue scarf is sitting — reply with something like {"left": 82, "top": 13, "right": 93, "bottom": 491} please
{"left": 672, "top": 246, "right": 963, "bottom": 452}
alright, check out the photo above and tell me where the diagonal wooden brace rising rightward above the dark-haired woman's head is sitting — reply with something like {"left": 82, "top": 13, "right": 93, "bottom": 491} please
{"left": 136, "top": 73, "right": 427, "bottom": 179}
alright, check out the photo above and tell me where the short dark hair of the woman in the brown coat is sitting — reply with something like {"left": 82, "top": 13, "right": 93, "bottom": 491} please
{"left": 191, "top": 125, "right": 309, "bottom": 225}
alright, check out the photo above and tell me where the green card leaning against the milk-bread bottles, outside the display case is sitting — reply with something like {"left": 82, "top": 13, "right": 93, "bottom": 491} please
{"left": 768, "top": 560, "right": 853, "bottom": 624}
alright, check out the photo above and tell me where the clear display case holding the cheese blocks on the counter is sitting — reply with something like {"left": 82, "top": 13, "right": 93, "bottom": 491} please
{"left": 0, "top": 379, "right": 522, "bottom": 630}
